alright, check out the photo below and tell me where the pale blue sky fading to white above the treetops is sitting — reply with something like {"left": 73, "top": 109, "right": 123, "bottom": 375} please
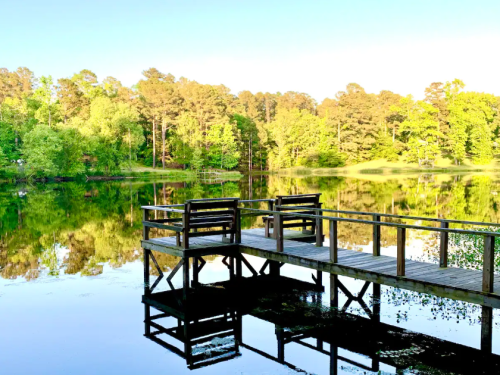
{"left": 0, "top": 0, "right": 500, "bottom": 101}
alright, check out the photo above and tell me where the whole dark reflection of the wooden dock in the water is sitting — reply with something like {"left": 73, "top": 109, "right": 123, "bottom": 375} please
{"left": 143, "top": 275, "right": 500, "bottom": 374}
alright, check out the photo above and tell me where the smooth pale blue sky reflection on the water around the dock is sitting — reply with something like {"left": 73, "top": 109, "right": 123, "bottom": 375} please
{"left": 0, "top": 253, "right": 500, "bottom": 374}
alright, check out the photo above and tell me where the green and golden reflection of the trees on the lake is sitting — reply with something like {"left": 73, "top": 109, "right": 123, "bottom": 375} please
{"left": 0, "top": 175, "right": 500, "bottom": 279}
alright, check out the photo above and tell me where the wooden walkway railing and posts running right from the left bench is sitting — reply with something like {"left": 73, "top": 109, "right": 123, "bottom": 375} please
{"left": 238, "top": 204, "right": 500, "bottom": 293}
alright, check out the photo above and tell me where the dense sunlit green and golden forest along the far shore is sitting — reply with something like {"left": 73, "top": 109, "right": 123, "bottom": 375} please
{"left": 0, "top": 68, "right": 500, "bottom": 177}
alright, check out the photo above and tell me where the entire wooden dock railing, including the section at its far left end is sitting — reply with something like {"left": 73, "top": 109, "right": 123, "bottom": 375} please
{"left": 142, "top": 198, "right": 500, "bottom": 293}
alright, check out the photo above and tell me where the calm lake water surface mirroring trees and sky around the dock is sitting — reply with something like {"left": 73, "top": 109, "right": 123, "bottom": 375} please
{"left": 0, "top": 174, "right": 500, "bottom": 375}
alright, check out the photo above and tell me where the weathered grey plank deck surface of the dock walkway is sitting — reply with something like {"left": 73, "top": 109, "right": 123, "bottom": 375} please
{"left": 142, "top": 228, "right": 500, "bottom": 308}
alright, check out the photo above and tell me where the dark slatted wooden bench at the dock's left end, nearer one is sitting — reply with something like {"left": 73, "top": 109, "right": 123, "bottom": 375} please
{"left": 143, "top": 198, "right": 239, "bottom": 249}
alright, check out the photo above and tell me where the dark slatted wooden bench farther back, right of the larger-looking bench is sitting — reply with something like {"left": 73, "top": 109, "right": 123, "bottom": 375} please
{"left": 262, "top": 193, "right": 321, "bottom": 237}
